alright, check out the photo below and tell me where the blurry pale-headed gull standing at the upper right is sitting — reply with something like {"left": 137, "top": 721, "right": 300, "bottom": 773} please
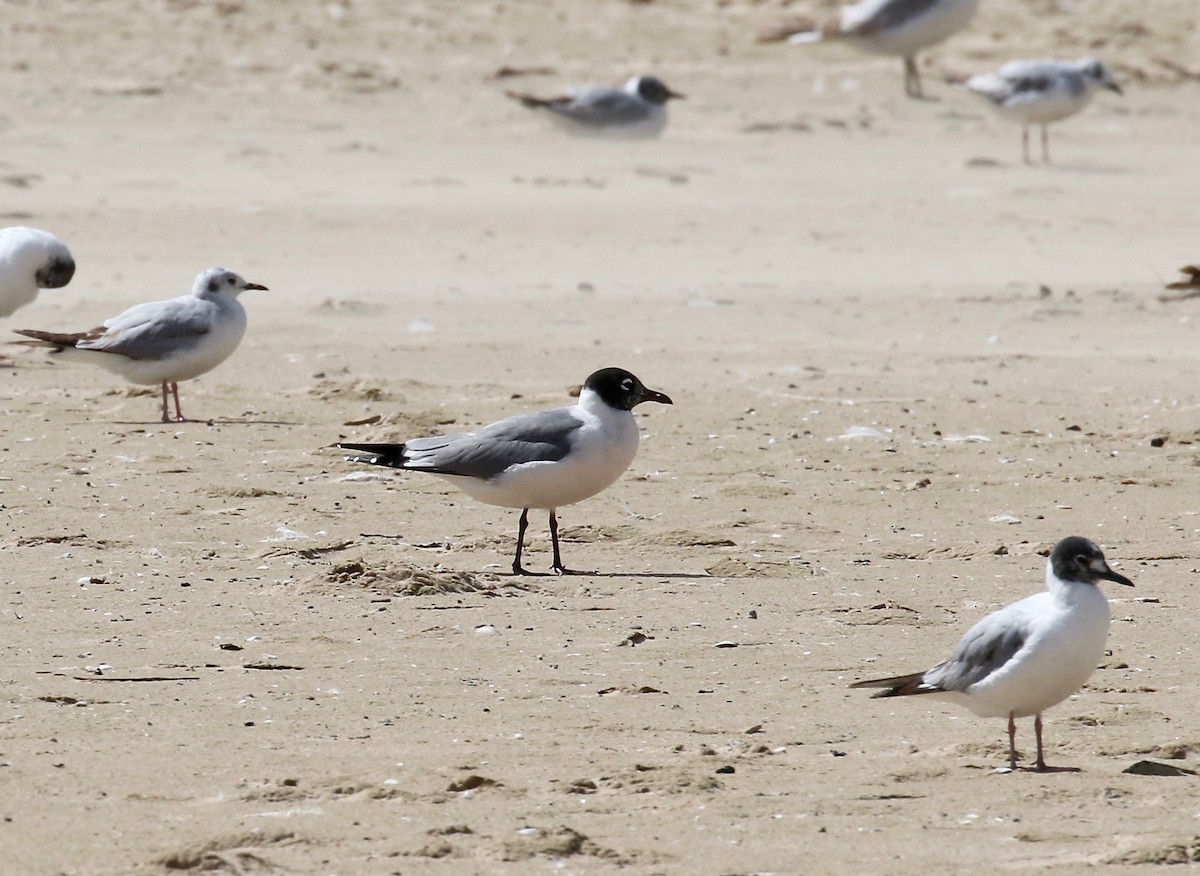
{"left": 954, "top": 58, "right": 1122, "bottom": 164}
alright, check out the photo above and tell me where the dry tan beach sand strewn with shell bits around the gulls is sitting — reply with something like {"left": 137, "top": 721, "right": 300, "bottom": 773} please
{"left": 0, "top": 0, "right": 1200, "bottom": 876}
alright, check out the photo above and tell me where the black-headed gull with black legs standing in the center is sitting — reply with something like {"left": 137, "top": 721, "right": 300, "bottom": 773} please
{"left": 337, "top": 368, "right": 673, "bottom": 575}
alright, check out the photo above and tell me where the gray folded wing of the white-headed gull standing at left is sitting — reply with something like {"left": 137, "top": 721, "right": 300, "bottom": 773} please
{"left": 77, "top": 295, "right": 212, "bottom": 359}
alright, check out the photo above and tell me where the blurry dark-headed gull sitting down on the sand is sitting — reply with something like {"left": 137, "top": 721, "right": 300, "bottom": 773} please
{"left": 504, "top": 76, "right": 683, "bottom": 138}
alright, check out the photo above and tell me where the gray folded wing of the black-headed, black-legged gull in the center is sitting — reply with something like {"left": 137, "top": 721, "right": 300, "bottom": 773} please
{"left": 404, "top": 408, "right": 583, "bottom": 480}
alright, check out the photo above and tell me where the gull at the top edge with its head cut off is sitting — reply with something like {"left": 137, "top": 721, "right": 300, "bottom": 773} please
{"left": 761, "top": 0, "right": 979, "bottom": 97}
